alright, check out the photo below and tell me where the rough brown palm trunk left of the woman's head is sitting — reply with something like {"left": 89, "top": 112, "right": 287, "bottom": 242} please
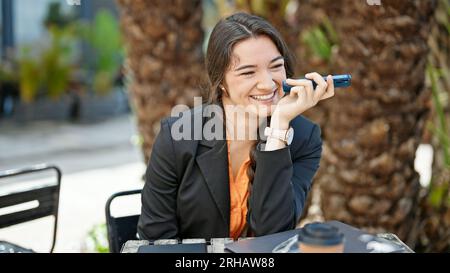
{"left": 117, "top": 0, "right": 205, "bottom": 162}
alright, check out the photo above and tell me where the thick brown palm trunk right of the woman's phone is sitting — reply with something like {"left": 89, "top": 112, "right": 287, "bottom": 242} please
{"left": 312, "top": 0, "right": 435, "bottom": 244}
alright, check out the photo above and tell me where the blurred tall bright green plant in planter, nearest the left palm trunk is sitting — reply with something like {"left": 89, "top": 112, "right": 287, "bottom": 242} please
{"left": 76, "top": 9, "right": 129, "bottom": 120}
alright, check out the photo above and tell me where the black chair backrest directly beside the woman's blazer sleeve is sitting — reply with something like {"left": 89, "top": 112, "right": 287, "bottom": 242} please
{"left": 105, "top": 190, "right": 142, "bottom": 253}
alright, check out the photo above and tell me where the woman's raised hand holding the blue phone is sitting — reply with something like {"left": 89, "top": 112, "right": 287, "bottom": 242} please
{"left": 270, "top": 72, "right": 334, "bottom": 129}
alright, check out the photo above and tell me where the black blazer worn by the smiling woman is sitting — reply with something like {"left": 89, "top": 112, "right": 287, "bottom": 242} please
{"left": 138, "top": 105, "right": 322, "bottom": 240}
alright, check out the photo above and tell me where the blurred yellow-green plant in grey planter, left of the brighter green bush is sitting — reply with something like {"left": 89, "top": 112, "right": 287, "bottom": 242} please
{"left": 12, "top": 26, "right": 75, "bottom": 121}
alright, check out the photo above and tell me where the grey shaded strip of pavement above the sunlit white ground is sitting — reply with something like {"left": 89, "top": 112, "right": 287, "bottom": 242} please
{"left": 0, "top": 115, "right": 142, "bottom": 173}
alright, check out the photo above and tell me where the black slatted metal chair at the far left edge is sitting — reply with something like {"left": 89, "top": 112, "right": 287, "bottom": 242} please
{"left": 0, "top": 164, "right": 62, "bottom": 252}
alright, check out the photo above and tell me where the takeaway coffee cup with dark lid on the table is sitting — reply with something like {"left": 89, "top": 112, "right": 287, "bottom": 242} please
{"left": 298, "top": 222, "right": 344, "bottom": 253}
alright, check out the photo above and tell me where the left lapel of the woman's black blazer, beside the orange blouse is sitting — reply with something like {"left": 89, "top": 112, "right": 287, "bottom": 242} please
{"left": 196, "top": 136, "right": 230, "bottom": 228}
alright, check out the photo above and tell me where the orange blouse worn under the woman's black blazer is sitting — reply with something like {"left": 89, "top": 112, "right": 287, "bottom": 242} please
{"left": 227, "top": 140, "right": 250, "bottom": 239}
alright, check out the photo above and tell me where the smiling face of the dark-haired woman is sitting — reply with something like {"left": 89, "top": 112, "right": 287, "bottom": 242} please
{"left": 222, "top": 36, "right": 286, "bottom": 116}
